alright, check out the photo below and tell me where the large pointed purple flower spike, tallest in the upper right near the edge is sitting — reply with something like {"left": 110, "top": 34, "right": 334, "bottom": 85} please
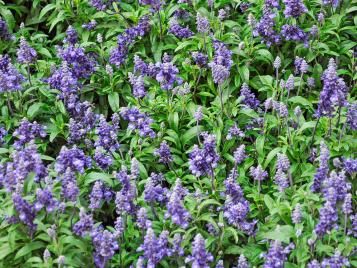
{"left": 316, "top": 59, "right": 348, "bottom": 117}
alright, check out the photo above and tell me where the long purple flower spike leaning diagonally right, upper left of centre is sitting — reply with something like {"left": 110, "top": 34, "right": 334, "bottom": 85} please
{"left": 109, "top": 16, "right": 150, "bottom": 67}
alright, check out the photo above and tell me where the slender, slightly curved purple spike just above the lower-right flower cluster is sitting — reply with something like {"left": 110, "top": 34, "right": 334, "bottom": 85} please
{"left": 311, "top": 142, "right": 330, "bottom": 193}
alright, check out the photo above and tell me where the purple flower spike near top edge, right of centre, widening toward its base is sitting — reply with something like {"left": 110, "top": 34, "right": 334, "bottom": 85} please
{"left": 253, "top": 8, "right": 281, "bottom": 47}
